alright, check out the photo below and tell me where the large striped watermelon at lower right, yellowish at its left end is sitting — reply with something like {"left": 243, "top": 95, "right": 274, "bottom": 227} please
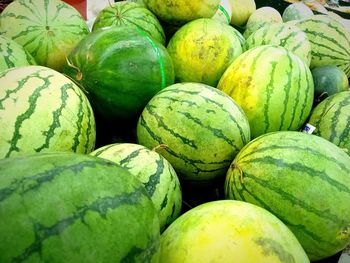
{"left": 225, "top": 131, "right": 350, "bottom": 261}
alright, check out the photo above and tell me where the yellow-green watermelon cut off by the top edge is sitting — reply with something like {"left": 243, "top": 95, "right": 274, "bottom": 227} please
{"left": 143, "top": 0, "right": 220, "bottom": 25}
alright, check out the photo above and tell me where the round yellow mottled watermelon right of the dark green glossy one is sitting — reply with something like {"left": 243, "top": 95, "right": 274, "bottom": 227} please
{"left": 167, "top": 18, "right": 242, "bottom": 87}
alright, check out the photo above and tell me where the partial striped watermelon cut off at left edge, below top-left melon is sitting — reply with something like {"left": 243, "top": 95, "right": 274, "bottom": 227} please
{"left": 0, "top": 35, "right": 36, "bottom": 72}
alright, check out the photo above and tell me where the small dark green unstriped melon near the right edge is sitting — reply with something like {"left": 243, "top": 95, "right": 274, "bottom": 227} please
{"left": 311, "top": 65, "right": 349, "bottom": 103}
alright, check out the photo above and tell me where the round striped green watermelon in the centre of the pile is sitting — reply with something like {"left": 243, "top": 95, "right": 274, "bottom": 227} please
{"left": 137, "top": 83, "right": 250, "bottom": 181}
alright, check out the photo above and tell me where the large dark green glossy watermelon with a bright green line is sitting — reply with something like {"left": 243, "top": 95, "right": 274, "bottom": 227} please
{"left": 64, "top": 26, "right": 174, "bottom": 120}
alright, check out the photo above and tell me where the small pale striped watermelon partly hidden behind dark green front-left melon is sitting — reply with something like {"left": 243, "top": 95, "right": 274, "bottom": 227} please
{"left": 91, "top": 143, "right": 182, "bottom": 230}
